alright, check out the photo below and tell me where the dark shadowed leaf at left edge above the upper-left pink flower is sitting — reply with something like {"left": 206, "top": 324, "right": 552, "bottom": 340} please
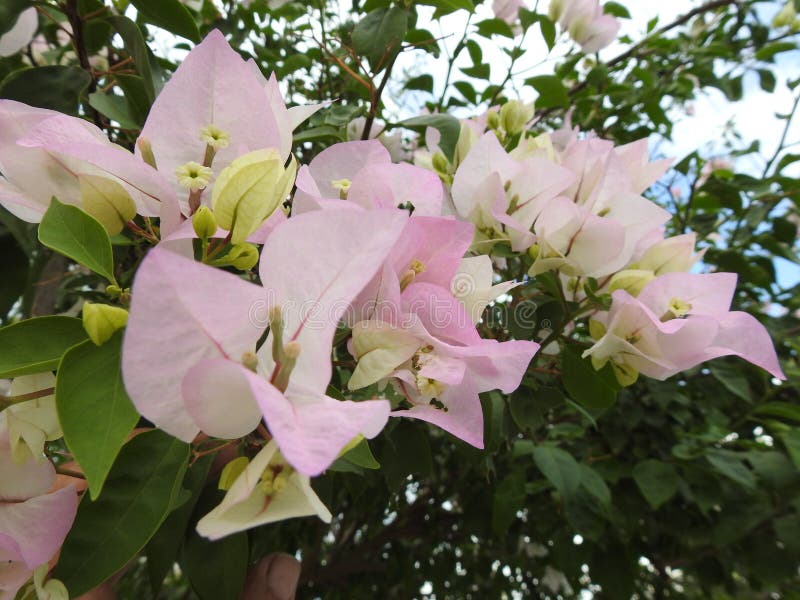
{"left": 0, "top": 65, "right": 92, "bottom": 115}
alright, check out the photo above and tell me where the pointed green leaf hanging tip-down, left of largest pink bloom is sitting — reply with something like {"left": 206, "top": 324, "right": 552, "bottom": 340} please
{"left": 56, "top": 331, "right": 139, "bottom": 500}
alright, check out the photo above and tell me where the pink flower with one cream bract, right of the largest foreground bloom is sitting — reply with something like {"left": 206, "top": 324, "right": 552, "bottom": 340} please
{"left": 348, "top": 284, "right": 539, "bottom": 448}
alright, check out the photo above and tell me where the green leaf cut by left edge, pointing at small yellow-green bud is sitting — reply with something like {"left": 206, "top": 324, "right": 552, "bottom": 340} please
{"left": 0, "top": 316, "right": 86, "bottom": 378}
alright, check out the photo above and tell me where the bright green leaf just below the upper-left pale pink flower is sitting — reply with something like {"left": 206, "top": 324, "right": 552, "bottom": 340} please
{"left": 39, "top": 198, "right": 117, "bottom": 284}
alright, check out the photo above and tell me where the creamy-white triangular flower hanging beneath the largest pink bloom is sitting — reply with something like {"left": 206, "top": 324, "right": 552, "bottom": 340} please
{"left": 197, "top": 442, "right": 332, "bottom": 540}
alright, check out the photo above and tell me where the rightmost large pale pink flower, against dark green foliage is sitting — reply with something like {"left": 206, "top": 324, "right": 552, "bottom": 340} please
{"left": 584, "top": 273, "right": 784, "bottom": 382}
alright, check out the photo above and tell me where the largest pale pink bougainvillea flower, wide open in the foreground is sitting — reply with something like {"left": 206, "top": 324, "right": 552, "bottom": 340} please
{"left": 123, "top": 210, "right": 407, "bottom": 475}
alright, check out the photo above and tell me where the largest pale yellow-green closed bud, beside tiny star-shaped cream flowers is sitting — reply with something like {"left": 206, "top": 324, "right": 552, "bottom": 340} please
{"left": 211, "top": 148, "right": 297, "bottom": 244}
